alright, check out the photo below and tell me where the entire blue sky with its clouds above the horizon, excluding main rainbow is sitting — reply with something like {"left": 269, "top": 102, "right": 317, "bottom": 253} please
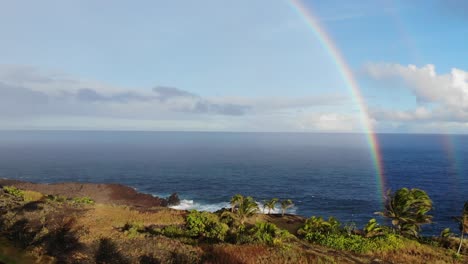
{"left": 0, "top": 0, "right": 468, "bottom": 133}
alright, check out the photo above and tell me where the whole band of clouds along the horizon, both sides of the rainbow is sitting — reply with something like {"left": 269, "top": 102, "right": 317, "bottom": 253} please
{"left": 0, "top": 63, "right": 468, "bottom": 133}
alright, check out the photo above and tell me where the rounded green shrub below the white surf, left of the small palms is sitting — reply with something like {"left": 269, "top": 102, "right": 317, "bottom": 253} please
{"left": 186, "top": 210, "right": 229, "bottom": 241}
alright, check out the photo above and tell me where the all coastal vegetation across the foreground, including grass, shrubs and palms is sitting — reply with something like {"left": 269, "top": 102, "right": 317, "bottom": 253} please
{"left": 0, "top": 186, "right": 468, "bottom": 263}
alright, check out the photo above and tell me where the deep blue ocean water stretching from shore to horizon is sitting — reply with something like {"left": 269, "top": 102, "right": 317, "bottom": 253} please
{"left": 0, "top": 131, "right": 468, "bottom": 235}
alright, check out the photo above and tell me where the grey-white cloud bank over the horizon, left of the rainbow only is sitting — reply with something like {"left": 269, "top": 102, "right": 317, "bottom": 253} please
{"left": 0, "top": 65, "right": 357, "bottom": 131}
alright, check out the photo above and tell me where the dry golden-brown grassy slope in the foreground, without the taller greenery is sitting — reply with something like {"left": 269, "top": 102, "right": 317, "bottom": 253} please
{"left": 0, "top": 182, "right": 466, "bottom": 263}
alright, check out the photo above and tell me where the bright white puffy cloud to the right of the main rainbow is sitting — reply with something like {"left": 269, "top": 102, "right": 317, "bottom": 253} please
{"left": 364, "top": 63, "right": 468, "bottom": 132}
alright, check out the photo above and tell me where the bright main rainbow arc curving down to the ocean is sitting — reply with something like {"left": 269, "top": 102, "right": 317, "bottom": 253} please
{"left": 288, "top": 0, "right": 385, "bottom": 202}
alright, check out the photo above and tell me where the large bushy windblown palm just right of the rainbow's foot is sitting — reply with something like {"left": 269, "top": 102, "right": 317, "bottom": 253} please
{"left": 377, "top": 188, "right": 432, "bottom": 236}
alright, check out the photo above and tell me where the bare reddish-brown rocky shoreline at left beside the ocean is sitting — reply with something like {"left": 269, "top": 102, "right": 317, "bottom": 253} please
{"left": 0, "top": 179, "right": 179, "bottom": 208}
